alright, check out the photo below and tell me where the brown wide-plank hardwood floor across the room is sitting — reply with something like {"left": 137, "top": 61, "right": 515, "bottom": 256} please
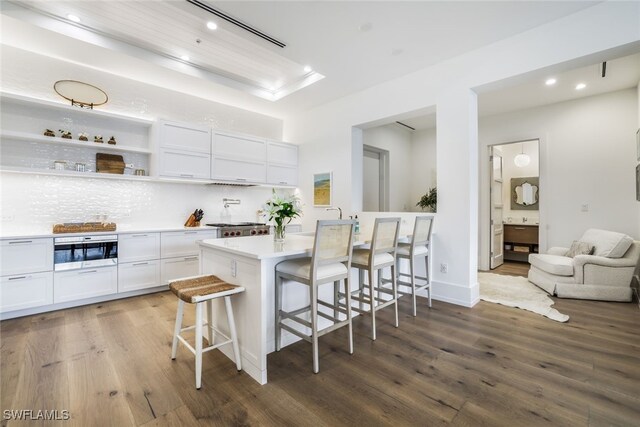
{"left": 0, "top": 292, "right": 640, "bottom": 426}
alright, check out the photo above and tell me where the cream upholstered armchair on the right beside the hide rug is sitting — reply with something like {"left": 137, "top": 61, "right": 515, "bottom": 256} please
{"left": 529, "top": 229, "right": 640, "bottom": 301}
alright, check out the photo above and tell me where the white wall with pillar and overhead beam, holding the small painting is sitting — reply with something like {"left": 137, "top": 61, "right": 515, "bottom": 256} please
{"left": 285, "top": 2, "right": 640, "bottom": 306}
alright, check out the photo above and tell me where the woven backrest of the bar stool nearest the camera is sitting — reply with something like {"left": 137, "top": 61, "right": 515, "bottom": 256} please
{"left": 311, "top": 220, "right": 355, "bottom": 279}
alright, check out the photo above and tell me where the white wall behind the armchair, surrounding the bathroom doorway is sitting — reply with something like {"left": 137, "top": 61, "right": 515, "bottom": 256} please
{"left": 480, "top": 89, "right": 640, "bottom": 269}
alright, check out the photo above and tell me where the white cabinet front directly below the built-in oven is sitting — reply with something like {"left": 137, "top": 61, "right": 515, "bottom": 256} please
{"left": 53, "top": 267, "right": 118, "bottom": 304}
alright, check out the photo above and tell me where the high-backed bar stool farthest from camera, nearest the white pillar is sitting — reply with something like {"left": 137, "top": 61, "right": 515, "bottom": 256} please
{"left": 396, "top": 216, "right": 433, "bottom": 316}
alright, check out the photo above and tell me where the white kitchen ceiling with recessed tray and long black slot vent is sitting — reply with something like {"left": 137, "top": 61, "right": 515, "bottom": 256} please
{"left": 2, "top": 0, "right": 597, "bottom": 117}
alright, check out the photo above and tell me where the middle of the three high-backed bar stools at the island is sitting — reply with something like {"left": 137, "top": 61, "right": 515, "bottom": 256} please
{"left": 348, "top": 217, "right": 400, "bottom": 340}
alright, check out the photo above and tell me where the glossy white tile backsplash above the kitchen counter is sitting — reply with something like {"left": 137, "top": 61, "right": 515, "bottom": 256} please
{"left": 0, "top": 173, "right": 293, "bottom": 234}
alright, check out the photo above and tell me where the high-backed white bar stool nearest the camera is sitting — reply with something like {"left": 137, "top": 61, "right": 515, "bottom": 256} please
{"left": 275, "top": 220, "right": 355, "bottom": 374}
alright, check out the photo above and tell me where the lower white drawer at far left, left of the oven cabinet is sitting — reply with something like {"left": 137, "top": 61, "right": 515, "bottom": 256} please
{"left": 0, "top": 272, "right": 53, "bottom": 313}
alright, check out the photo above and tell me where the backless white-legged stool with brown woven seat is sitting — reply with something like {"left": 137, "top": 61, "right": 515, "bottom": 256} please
{"left": 169, "top": 275, "right": 244, "bottom": 390}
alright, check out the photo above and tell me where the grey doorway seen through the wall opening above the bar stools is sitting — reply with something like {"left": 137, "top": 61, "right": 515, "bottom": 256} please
{"left": 362, "top": 145, "right": 389, "bottom": 212}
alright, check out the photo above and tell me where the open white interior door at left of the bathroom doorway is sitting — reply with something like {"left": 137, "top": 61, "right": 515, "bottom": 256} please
{"left": 489, "top": 147, "right": 504, "bottom": 269}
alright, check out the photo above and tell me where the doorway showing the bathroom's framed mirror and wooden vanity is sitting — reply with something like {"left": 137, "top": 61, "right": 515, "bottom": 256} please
{"left": 489, "top": 139, "right": 541, "bottom": 275}
